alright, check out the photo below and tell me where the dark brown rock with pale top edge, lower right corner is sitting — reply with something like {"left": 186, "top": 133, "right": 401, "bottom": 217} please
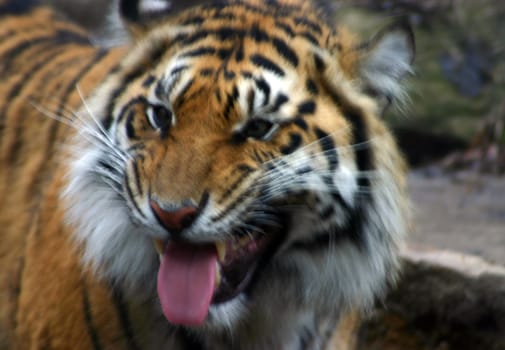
{"left": 352, "top": 249, "right": 505, "bottom": 350}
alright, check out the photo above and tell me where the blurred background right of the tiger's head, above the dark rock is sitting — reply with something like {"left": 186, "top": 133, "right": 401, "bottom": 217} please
{"left": 330, "top": 0, "right": 505, "bottom": 265}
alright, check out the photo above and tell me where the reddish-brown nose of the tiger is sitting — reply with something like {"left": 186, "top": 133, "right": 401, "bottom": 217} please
{"left": 150, "top": 200, "right": 198, "bottom": 234}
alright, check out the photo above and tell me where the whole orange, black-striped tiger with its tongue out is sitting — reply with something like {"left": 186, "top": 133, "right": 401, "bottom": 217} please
{"left": 0, "top": 0, "right": 415, "bottom": 350}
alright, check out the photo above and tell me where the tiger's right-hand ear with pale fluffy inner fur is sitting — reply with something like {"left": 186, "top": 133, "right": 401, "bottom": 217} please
{"left": 356, "top": 23, "right": 415, "bottom": 105}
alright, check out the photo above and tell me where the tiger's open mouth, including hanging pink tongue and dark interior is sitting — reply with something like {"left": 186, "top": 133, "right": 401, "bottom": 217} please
{"left": 155, "top": 217, "right": 287, "bottom": 326}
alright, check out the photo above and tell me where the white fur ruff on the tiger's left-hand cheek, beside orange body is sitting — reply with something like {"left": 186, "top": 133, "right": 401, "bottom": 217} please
{"left": 63, "top": 144, "right": 158, "bottom": 293}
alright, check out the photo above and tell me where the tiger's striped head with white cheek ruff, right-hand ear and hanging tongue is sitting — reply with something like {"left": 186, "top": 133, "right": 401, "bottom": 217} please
{"left": 65, "top": 2, "right": 412, "bottom": 334}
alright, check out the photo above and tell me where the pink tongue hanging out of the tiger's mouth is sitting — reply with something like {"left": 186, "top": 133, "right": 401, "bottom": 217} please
{"left": 158, "top": 243, "right": 217, "bottom": 326}
